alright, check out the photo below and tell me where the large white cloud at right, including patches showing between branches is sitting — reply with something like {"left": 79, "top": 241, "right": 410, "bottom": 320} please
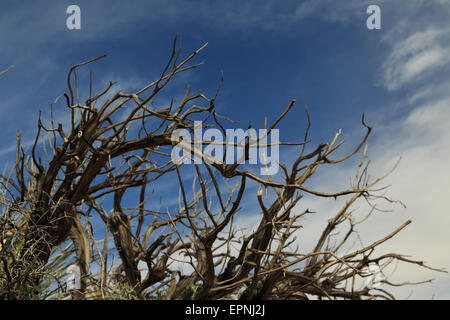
{"left": 229, "top": 84, "right": 450, "bottom": 299}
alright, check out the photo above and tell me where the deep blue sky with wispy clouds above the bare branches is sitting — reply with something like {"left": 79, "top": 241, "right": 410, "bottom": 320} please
{"left": 0, "top": 0, "right": 450, "bottom": 299}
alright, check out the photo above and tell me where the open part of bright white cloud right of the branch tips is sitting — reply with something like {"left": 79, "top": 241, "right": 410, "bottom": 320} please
{"left": 362, "top": 94, "right": 450, "bottom": 299}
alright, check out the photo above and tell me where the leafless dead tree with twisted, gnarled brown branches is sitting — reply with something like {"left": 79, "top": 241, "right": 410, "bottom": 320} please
{"left": 0, "top": 39, "right": 440, "bottom": 299}
